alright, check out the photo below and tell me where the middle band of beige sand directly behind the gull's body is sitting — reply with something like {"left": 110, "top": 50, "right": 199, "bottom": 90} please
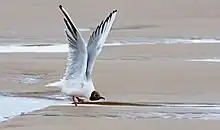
{"left": 0, "top": 44, "right": 220, "bottom": 102}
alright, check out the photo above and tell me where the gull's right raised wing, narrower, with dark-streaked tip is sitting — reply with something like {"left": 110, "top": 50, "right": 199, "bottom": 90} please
{"left": 86, "top": 10, "right": 117, "bottom": 78}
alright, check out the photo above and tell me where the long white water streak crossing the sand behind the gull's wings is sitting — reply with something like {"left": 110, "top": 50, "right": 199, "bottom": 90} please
{"left": 0, "top": 38, "right": 220, "bottom": 53}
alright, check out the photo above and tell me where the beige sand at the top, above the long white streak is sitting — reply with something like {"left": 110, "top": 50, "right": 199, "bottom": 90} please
{"left": 0, "top": 0, "right": 220, "bottom": 42}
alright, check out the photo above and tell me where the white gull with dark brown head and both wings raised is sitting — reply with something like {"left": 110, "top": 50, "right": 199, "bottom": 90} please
{"left": 45, "top": 5, "right": 118, "bottom": 106}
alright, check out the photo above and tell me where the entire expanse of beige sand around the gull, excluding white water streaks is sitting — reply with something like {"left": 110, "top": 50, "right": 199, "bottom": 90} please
{"left": 0, "top": 0, "right": 220, "bottom": 130}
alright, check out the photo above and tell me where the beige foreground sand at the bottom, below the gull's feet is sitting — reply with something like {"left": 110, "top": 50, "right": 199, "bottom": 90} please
{"left": 0, "top": 107, "right": 219, "bottom": 130}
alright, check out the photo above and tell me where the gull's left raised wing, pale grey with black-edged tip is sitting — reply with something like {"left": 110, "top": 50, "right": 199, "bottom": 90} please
{"left": 59, "top": 5, "right": 88, "bottom": 80}
